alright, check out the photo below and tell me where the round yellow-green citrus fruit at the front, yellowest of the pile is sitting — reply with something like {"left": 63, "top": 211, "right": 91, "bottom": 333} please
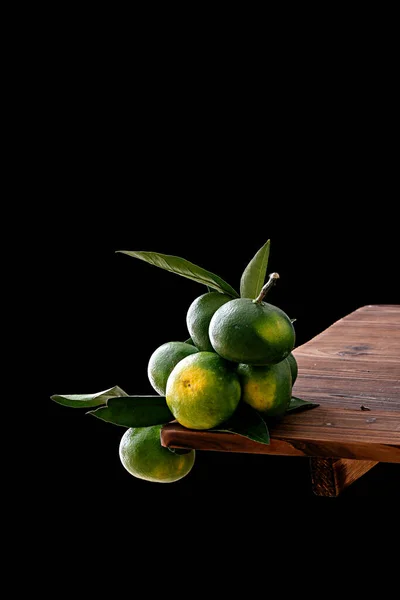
{"left": 166, "top": 352, "right": 241, "bottom": 429}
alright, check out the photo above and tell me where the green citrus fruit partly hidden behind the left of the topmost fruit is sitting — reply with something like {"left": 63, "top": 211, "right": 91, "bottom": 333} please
{"left": 186, "top": 292, "right": 232, "bottom": 352}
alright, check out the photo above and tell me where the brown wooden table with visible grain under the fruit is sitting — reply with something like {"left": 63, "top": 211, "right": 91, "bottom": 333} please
{"left": 161, "top": 305, "right": 400, "bottom": 496}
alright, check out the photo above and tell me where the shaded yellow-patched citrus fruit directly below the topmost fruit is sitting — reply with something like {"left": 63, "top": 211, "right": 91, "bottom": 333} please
{"left": 237, "top": 359, "right": 292, "bottom": 417}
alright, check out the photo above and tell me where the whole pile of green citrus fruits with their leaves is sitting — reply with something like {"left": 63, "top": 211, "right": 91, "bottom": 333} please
{"left": 52, "top": 240, "right": 316, "bottom": 483}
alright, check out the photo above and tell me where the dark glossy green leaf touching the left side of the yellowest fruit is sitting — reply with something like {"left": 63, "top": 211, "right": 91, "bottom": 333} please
{"left": 86, "top": 396, "right": 174, "bottom": 427}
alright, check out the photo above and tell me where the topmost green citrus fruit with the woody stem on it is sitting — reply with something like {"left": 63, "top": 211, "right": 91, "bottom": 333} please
{"left": 209, "top": 298, "right": 295, "bottom": 365}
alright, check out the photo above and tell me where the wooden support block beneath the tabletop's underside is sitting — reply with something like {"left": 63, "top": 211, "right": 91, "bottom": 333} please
{"left": 310, "top": 457, "right": 378, "bottom": 496}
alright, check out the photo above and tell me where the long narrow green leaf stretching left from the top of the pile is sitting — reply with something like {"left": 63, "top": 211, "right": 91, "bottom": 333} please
{"left": 118, "top": 250, "right": 239, "bottom": 298}
